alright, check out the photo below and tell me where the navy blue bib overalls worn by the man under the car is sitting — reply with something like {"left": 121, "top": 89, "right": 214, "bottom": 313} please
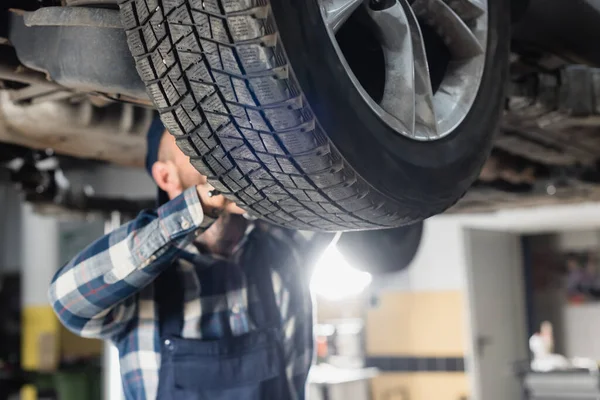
{"left": 156, "top": 230, "right": 308, "bottom": 400}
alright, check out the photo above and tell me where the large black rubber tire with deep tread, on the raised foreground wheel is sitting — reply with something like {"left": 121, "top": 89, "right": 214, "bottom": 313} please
{"left": 119, "top": 0, "right": 510, "bottom": 231}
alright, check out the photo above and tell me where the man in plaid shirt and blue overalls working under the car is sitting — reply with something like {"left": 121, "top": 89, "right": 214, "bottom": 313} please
{"left": 49, "top": 119, "right": 314, "bottom": 400}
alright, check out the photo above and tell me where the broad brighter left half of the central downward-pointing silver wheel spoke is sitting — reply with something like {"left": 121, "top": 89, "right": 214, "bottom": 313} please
{"left": 369, "top": 2, "right": 415, "bottom": 136}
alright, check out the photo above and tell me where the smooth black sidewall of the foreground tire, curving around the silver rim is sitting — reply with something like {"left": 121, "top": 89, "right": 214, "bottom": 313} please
{"left": 271, "top": 0, "right": 510, "bottom": 203}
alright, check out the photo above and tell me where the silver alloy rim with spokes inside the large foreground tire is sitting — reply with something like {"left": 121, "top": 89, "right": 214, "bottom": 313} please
{"left": 318, "top": 0, "right": 488, "bottom": 141}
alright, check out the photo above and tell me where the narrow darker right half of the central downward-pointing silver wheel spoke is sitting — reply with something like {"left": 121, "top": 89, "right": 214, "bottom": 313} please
{"left": 399, "top": 0, "right": 437, "bottom": 139}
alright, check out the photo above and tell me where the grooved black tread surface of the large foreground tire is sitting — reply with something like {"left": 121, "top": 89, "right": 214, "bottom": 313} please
{"left": 119, "top": 0, "right": 426, "bottom": 231}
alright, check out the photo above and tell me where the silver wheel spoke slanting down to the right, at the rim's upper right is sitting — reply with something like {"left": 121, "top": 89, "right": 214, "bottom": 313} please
{"left": 412, "top": 0, "right": 484, "bottom": 60}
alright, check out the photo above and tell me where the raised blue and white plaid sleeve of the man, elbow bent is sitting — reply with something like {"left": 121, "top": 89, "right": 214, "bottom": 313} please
{"left": 49, "top": 187, "right": 206, "bottom": 339}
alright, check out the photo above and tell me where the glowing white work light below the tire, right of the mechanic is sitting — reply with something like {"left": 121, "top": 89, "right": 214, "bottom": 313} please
{"left": 310, "top": 246, "right": 372, "bottom": 300}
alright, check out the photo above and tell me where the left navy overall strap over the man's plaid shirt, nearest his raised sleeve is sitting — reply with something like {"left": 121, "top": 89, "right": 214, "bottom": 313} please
{"left": 155, "top": 262, "right": 183, "bottom": 338}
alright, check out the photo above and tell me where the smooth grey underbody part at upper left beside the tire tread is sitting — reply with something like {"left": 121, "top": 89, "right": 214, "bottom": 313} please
{"left": 8, "top": 7, "right": 149, "bottom": 104}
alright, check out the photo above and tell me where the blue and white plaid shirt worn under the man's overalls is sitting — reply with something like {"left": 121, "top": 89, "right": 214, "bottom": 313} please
{"left": 49, "top": 188, "right": 312, "bottom": 400}
